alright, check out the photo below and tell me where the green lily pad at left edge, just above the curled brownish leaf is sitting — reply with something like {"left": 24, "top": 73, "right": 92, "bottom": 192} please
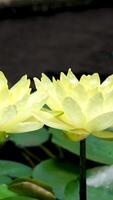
{"left": 0, "top": 160, "right": 32, "bottom": 177}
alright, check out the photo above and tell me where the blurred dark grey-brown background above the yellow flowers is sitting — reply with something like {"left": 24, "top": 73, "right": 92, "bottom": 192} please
{"left": 0, "top": 0, "right": 113, "bottom": 84}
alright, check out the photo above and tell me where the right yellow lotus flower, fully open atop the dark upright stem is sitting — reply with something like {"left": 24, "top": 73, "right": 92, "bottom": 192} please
{"left": 34, "top": 69, "right": 113, "bottom": 141}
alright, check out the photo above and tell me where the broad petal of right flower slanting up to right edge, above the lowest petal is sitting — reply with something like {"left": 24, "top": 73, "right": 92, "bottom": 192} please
{"left": 87, "top": 112, "right": 113, "bottom": 132}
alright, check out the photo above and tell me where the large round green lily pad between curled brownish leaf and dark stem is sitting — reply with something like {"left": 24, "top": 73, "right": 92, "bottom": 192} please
{"left": 33, "top": 159, "right": 78, "bottom": 199}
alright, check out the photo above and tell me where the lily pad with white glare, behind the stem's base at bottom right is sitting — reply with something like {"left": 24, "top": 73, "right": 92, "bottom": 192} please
{"left": 64, "top": 165, "right": 113, "bottom": 200}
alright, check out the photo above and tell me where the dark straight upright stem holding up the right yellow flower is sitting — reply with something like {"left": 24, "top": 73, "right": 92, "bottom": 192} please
{"left": 80, "top": 139, "right": 87, "bottom": 200}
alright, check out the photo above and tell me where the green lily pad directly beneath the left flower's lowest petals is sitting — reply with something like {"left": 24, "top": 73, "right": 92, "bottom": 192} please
{"left": 9, "top": 128, "right": 49, "bottom": 147}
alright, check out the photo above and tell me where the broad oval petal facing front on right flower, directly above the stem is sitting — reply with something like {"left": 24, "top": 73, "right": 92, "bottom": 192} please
{"left": 62, "top": 97, "right": 85, "bottom": 128}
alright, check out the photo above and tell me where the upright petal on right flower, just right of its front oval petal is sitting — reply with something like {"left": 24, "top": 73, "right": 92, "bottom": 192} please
{"left": 85, "top": 92, "right": 103, "bottom": 120}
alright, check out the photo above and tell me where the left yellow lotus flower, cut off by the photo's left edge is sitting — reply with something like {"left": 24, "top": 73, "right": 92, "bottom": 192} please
{"left": 0, "top": 72, "right": 46, "bottom": 137}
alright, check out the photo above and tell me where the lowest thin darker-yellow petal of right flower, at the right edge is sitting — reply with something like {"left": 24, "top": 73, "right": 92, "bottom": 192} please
{"left": 92, "top": 130, "right": 113, "bottom": 139}
